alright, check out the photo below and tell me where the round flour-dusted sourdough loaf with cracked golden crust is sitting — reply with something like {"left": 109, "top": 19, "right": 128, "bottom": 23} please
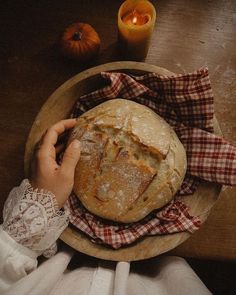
{"left": 69, "top": 99, "right": 186, "bottom": 223}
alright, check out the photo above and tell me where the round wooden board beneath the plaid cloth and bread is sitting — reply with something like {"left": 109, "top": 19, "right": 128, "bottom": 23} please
{"left": 24, "top": 61, "right": 221, "bottom": 261}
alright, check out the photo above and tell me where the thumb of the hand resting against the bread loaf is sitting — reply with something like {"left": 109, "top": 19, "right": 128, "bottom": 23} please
{"left": 61, "top": 139, "right": 80, "bottom": 175}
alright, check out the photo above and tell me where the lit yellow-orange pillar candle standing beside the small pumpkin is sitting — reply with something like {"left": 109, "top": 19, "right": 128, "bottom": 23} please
{"left": 118, "top": 0, "right": 156, "bottom": 60}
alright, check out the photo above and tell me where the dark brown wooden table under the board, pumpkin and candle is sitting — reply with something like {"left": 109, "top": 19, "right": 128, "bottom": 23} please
{"left": 0, "top": 0, "right": 236, "bottom": 260}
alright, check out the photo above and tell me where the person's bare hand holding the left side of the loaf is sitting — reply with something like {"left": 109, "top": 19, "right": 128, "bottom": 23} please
{"left": 30, "top": 119, "right": 80, "bottom": 208}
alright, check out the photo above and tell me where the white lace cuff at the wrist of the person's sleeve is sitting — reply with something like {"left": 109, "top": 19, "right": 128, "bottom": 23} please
{"left": 2, "top": 179, "right": 69, "bottom": 257}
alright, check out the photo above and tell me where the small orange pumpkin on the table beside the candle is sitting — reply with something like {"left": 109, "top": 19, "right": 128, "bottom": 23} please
{"left": 61, "top": 22, "right": 101, "bottom": 62}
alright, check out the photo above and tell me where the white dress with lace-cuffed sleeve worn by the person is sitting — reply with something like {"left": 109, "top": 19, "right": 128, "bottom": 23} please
{"left": 0, "top": 180, "right": 211, "bottom": 295}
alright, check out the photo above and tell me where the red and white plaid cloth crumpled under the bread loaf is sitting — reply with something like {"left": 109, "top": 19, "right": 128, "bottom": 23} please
{"left": 66, "top": 68, "right": 236, "bottom": 249}
